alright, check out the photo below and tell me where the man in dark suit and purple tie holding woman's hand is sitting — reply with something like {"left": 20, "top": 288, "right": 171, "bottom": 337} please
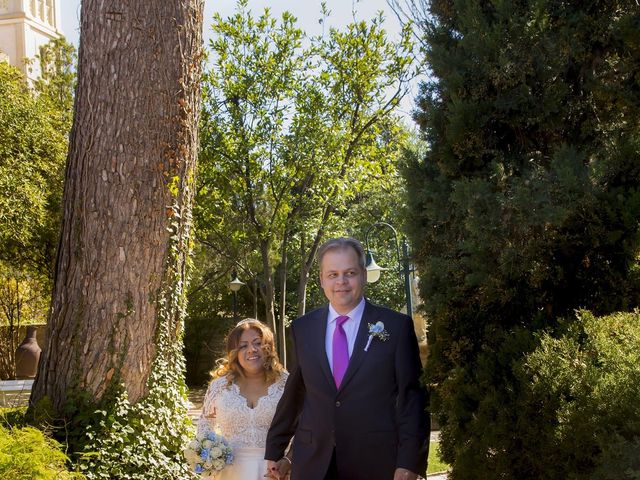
{"left": 265, "top": 238, "right": 429, "bottom": 480}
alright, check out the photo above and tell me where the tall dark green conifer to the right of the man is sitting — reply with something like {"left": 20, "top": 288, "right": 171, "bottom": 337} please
{"left": 405, "top": 0, "right": 640, "bottom": 479}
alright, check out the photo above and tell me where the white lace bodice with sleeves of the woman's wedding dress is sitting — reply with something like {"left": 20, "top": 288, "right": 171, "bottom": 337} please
{"left": 198, "top": 373, "right": 288, "bottom": 449}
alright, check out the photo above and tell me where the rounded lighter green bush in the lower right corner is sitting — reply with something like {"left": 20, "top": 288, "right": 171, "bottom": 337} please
{"left": 512, "top": 311, "right": 640, "bottom": 480}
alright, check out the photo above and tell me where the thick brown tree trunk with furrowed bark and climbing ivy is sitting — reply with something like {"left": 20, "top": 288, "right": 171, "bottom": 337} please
{"left": 32, "top": 0, "right": 202, "bottom": 411}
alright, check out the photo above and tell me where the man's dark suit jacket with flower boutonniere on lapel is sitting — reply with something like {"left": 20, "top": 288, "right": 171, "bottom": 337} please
{"left": 265, "top": 301, "right": 429, "bottom": 480}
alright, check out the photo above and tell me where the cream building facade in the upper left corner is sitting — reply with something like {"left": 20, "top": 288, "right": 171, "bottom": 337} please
{"left": 0, "top": 0, "right": 62, "bottom": 79}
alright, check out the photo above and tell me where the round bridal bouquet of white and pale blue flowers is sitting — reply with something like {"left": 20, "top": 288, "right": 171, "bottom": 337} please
{"left": 184, "top": 432, "right": 233, "bottom": 475}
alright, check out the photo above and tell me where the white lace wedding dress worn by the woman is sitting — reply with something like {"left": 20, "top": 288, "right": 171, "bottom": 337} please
{"left": 198, "top": 373, "right": 287, "bottom": 480}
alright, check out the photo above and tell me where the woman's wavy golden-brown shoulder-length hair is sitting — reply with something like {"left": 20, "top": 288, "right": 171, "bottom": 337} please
{"left": 211, "top": 318, "right": 284, "bottom": 385}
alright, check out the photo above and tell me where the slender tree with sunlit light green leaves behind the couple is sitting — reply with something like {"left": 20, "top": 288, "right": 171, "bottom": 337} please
{"left": 197, "top": 1, "right": 411, "bottom": 360}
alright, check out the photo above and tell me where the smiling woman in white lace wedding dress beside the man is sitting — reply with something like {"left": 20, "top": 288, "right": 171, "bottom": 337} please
{"left": 198, "top": 318, "right": 291, "bottom": 480}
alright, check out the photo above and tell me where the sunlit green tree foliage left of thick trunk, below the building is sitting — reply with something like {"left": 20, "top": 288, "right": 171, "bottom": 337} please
{"left": 0, "top": 39, "right": 75, "bottom": 282}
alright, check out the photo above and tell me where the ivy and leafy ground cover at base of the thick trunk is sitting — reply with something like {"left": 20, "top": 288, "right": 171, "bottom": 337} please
{"left": 59, "top": 316, "right": 193, "bottom": 480}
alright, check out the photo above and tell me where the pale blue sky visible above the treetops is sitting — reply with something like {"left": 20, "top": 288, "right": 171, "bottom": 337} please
{"left": 60, "top": 0, "right": 418, "bottom": 120}
